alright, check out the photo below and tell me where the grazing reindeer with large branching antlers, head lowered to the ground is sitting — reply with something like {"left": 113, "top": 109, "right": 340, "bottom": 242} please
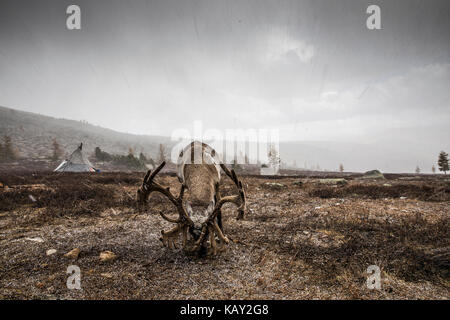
{"left": 137, "top": 141, "right": 246, "bottom": 255}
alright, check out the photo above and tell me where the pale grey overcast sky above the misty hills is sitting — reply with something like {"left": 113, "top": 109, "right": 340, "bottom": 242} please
{"left": 0, "top": 0, "right": 450, "bottom": 144}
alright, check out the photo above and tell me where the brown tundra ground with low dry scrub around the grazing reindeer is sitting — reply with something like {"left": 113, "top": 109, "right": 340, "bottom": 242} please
{"left": 0, "top": 173, "right": 450, "bottom": 299}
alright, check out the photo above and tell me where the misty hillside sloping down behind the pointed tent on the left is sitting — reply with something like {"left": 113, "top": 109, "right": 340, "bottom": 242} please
{"left": 0, "top": 106, "right": 170, "bottom": 159}
